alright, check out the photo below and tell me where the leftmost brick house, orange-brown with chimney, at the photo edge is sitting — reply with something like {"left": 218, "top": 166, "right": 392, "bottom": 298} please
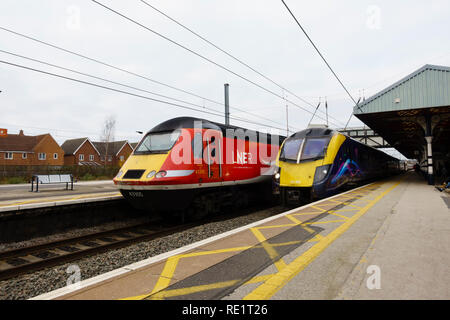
{"left": 0, "top": 130, "right": 64, "bottom": 166}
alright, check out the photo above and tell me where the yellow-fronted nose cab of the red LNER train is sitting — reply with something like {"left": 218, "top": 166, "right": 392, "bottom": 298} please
{"left": 113, "top": 128, "right": 223, "bottom": 211}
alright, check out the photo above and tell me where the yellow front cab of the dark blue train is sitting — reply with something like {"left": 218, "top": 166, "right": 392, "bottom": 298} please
{"left": 274, "top": 129, "right": 332, "bottom": 205}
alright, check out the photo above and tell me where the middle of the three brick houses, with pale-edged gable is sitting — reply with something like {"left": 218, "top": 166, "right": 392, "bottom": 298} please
{"left": 61, "top": 138, "right": 101, "bottom": 166}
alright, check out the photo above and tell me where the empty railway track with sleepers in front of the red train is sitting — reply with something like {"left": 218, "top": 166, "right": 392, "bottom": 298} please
{"left": 0, "top": 222, "right": 198, "bottom": 280}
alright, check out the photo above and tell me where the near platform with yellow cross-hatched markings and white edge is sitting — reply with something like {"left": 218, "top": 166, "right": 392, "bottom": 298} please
{"left": 34, "top": 172, "right": 450, "bottom": 300}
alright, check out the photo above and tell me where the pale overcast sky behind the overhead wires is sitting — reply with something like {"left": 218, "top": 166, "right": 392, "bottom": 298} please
{"left": 0, "top": 0, "right": 450, "bottom": 159}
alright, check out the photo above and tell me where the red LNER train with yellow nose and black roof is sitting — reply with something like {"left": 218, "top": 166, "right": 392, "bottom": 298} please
{"left": 114, "top": 117, "right": 284, "bottom": 214}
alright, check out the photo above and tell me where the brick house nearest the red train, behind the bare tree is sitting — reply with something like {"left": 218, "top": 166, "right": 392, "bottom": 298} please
{"left": 93, "top": 140, "right": 133, "bottom": 167}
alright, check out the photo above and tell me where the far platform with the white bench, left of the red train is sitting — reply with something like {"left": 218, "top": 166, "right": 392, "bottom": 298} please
{"left": 0, "top": 180, "right": 122, "bottom": 213}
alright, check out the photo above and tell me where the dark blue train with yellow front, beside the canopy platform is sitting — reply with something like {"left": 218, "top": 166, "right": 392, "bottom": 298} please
{"left": 274, "top": 127, "right": 400, "bottom": 205}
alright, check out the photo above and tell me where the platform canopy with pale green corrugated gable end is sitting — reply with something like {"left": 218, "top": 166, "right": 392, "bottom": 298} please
{"left": 354, "top": 65, "right": 450, "bottom": 165}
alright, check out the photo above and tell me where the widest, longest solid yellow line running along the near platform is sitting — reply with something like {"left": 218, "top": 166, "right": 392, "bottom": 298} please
{"left": 244, "top": 181, "right": 401, "bottom": 300}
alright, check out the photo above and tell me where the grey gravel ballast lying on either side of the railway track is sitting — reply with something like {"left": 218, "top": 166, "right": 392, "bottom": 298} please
{"left": 0, "top": 207, "right": 283, "bottom": 300}
